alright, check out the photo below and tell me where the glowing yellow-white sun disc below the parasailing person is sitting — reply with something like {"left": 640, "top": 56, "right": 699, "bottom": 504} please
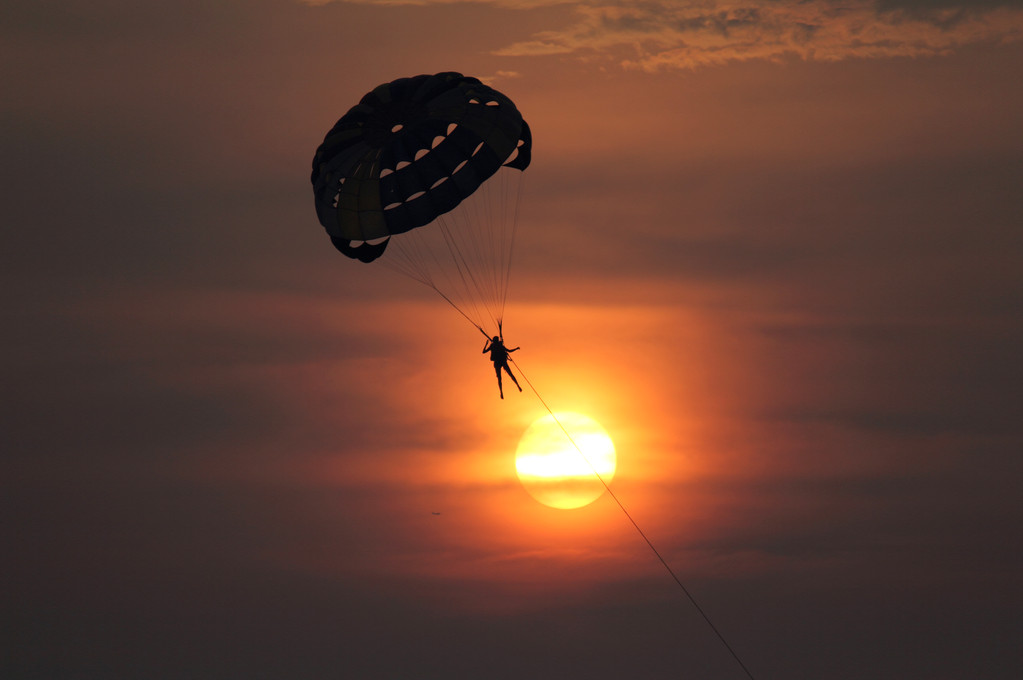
{"left": 515, "top": 412, "right": 615, "bottom": 510}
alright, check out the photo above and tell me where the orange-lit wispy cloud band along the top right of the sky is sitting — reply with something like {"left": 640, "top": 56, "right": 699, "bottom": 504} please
{"left": 307, "top": 0, "right": 1023, "bottom": 67}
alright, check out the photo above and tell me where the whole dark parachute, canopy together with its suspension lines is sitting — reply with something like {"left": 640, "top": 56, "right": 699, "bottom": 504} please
{"left": 312, "top": 72, "right": 532, "bottom": 335}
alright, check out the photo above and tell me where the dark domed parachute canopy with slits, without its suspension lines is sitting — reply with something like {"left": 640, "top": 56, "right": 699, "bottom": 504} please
{"left": 312, "top": 72, "right": 532, "bottom": 262}
